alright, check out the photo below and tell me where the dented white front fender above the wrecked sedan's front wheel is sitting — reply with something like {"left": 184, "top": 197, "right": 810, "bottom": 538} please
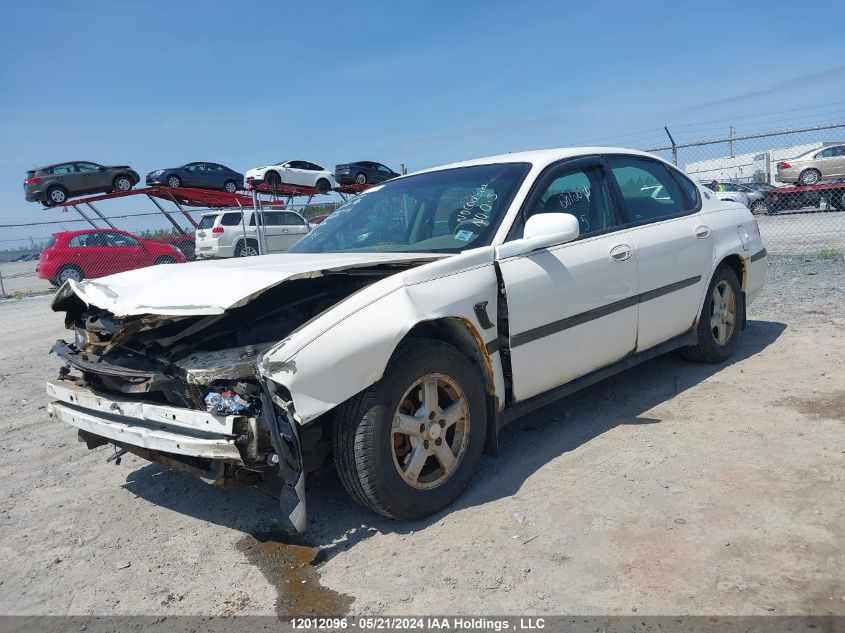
{"left": 258, "top": 248, "right": 504, "bottom": 424}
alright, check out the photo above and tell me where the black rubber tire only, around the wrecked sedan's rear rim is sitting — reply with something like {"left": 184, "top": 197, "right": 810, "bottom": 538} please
{"left": 681, "top": 264, "right": 745, "bottom": 363}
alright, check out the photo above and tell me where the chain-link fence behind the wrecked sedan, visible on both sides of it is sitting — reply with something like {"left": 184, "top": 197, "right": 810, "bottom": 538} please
{"left": 0, "top": 123, "right": 845, "bottom": 297}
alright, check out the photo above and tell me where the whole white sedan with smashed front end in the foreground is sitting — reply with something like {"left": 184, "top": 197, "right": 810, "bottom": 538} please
{"left": 47, "top": 148, "right": 766, "bottom": 532}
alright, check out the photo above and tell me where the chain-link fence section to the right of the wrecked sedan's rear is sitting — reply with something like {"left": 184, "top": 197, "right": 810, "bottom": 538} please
{"left": 647, "top": 124, "right": 845, "bottom": 259}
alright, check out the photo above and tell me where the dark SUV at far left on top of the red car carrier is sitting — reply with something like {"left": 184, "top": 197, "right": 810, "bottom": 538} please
{"left": 23, "top": 161, "right": 141, "bottom": 207}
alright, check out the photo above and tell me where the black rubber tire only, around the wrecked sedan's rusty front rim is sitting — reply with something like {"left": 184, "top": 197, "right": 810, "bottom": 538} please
{"left": 333, "top": 339, "right": 487, "bottom": 520}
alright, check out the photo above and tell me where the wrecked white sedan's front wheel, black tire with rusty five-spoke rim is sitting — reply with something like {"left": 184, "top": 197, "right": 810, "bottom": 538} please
{"left": 333, "top": 339, "right": 487, "bottom": 519}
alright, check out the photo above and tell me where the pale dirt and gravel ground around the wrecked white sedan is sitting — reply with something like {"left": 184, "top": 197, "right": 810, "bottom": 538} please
{"left": 0, "top": 255, "right": 845, "bottom": 615}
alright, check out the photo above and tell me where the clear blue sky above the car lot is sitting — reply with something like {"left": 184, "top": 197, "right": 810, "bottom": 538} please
{"left": 0, "top": 0, "right": 845, "bottom": 243}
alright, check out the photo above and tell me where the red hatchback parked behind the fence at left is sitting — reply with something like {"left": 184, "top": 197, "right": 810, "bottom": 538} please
{"left": 35, "top": 229, "right": 185, "bottom": 286}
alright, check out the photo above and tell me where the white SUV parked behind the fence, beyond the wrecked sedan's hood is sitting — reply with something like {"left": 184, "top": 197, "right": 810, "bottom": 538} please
{"left": 195, "top": 209, "right": 311, "bottom": 259}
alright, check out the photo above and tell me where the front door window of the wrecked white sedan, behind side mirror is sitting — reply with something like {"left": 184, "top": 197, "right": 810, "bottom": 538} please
{"left": 525, "top": 166, "right": 617, "bottom": 237}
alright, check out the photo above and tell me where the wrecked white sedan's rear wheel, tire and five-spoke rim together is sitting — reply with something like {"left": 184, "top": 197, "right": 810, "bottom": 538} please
{"left": 681, "top": 264, "right": 745, "bottom": 363}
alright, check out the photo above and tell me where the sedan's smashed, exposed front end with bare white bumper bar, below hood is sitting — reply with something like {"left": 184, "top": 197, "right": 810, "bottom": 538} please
{"left": 47, "top": 258, "right": 436, "bottom": 532}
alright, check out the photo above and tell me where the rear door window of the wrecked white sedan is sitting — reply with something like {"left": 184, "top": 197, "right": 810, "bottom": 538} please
{"left": 607, "top": 156, "right": 692, "bottom": 224}
